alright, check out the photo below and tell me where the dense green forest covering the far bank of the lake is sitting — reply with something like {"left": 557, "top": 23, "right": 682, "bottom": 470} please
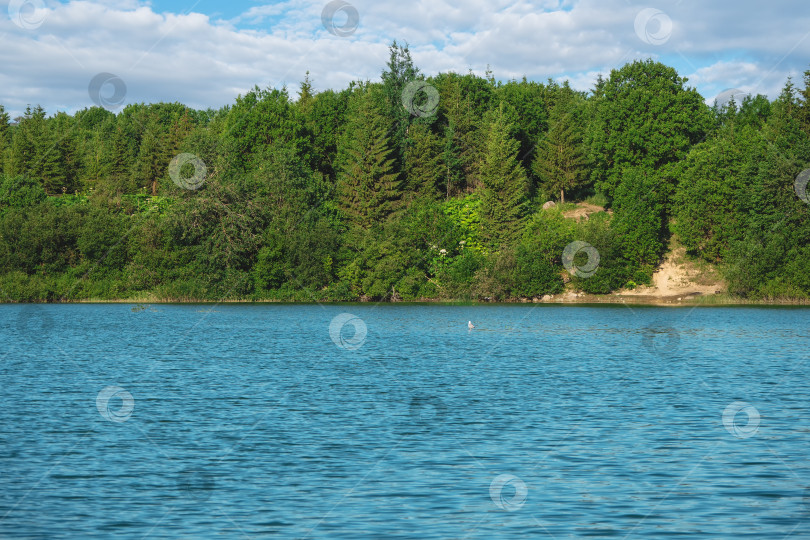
{"left": 0, "top": 42, "right": 810, "bottom": 302}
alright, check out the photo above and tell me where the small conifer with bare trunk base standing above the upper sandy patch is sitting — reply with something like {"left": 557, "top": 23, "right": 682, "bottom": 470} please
{"left": 532, "top": 106, "right": 586, "bottom": 203}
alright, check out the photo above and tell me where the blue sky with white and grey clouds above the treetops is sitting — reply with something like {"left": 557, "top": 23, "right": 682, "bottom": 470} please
{"left": 0, "top": 0, "right": 810, "bottom": 116}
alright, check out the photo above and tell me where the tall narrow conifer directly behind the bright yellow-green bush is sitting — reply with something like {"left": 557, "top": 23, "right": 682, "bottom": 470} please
{"left": 480, "top": 103, "right": 529, "bottom": 248}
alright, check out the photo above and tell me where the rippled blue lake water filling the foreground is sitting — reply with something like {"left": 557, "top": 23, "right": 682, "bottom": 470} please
{"left": 0, "top": 305, "right": 810, "bottom": 539}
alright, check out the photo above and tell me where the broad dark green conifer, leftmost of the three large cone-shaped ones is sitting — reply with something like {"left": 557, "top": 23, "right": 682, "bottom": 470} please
{"left": 338, "top": 90, "right": 402, "bottom": 230}
